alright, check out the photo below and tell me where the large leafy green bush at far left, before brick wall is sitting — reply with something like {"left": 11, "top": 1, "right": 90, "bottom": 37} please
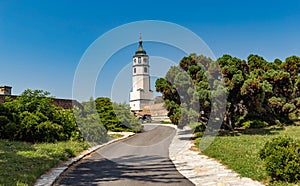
{"left": 0, "top": 89, "right": 80, "bottom": 142}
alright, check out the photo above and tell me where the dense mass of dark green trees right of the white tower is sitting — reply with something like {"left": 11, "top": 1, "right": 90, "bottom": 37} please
{"left": 155, "top": 54, "right": 300, "bottom": 129}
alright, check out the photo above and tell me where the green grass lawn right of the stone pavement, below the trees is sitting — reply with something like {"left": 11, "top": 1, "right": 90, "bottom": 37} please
{"left": 195, "top": 126, "right": 300, "bottom": 186}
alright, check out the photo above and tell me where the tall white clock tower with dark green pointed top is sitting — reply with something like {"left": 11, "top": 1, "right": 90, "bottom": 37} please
{"left": 130, "top": 37, "right": 154, "bottom": 112}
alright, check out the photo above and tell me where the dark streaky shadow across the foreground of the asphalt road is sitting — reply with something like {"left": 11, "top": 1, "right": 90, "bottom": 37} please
{"left": 55, "top": 153, "right": 193, "bottom": 186}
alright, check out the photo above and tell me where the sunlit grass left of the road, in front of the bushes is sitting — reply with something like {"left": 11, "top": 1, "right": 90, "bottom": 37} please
{"left": 0, "top": 140, "right": 88, "bottom": 185}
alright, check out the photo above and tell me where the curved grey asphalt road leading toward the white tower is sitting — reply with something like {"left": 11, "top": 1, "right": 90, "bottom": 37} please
{"left": 54, "top": 125, "right": 193, "bottom": 186}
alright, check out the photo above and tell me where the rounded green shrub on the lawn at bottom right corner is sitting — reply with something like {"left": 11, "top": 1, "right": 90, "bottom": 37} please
{"left": 259, "top": 136, "right": 300, "bottom": 182}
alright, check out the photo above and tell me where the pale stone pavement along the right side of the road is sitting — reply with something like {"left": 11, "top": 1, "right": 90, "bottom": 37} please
{"left": 169, "top": 124, "right": 263, "bottom": 186}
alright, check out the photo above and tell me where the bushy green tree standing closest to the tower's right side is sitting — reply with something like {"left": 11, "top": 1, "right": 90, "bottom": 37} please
{"left": 155, "top": 54, "right": 218, "bottom": 128}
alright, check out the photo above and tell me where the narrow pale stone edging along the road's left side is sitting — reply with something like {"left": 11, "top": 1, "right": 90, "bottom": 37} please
{"left": 34, "top": 132, "right": 135, "bottom": 186}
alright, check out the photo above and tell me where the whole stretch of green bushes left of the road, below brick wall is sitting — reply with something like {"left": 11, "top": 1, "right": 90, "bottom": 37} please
{"left": 0, "top": 89, "right": 142, "bottom": 144}
